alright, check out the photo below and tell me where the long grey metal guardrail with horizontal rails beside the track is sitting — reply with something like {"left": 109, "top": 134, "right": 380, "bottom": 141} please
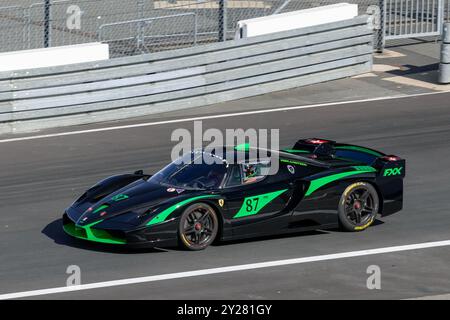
{"left": 0, "top": 16, "right": 373, "bottom": 133}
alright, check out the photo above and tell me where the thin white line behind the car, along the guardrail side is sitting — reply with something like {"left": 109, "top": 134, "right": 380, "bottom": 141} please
{"left": 0, "top": 92, "right": 447, "bottom": 143}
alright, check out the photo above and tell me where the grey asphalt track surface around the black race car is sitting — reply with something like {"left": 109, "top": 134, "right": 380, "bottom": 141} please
{"left": 0, "top": 93, "right": 450, "bottom": 299}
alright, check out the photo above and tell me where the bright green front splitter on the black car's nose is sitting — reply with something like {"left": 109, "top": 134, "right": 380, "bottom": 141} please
{"left": 63, "top": 220, "right": 127, "bottom": 244}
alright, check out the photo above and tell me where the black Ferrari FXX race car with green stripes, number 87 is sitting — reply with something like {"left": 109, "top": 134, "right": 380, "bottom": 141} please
{"left": 63, "top": 139, "right": 406, "bottom": 250}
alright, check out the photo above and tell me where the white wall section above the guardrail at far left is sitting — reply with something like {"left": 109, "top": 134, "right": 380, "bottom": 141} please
{"left": 0, "top": 42, "right": 109, "bottom": 71}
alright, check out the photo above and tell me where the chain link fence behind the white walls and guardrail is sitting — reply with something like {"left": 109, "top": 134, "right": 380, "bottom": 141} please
{"left": 0, "top": 0, "right": 450, "bottom": 57}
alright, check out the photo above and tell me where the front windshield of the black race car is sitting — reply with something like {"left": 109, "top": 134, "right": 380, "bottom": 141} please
{"left": 149, "top": 152, "right": 227, "bottom": 190}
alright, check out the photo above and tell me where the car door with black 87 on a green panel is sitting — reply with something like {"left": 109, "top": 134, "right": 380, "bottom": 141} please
{"left": 222, "top": 161, "right": 293, "bottom": 236}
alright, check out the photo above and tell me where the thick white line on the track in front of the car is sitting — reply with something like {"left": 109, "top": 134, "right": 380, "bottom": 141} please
{"left": 0, "top": 240, "right": 450, "bottom": 300}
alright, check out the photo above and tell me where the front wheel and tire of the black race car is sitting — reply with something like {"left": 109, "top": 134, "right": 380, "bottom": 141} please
{"left": 178, "top": 203, "right": 219, "bottom": 251}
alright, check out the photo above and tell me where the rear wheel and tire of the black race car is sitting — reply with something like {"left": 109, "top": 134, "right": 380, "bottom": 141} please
{"left": 338, "top": 182, "right": 380, "bottom": 232}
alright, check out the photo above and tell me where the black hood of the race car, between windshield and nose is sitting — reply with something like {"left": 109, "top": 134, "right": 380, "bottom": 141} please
{"left": 77, "top": 179, "right": 193, "bottom": 226}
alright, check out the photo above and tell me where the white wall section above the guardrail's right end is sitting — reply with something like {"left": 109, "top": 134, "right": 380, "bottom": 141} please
{"left": 236, "top": 3, "right": 358, "bottom": 39}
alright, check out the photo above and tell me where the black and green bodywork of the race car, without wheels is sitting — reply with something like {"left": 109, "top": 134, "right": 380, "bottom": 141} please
{"left": 63, "top": 139, "right": 406, "bottom": 247}
